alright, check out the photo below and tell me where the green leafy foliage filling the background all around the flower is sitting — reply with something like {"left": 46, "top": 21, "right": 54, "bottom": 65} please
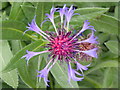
{"left": 0, "top": 2, "right": 120, "bottom": 88}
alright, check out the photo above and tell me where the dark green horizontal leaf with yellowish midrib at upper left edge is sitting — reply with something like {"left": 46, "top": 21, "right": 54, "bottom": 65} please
{"left": 0, "top": 20, "right": 34, "bottom": 40}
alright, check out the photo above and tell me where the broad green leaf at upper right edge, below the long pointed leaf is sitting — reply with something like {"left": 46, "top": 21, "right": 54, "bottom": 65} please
{"left": 91, "top": 14, "right": 118, "bottom": 35}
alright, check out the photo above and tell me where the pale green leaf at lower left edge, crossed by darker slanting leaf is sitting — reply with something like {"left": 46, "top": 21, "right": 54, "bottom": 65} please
{"left": 0, "top": 41, "right": 18, "bottom": 88}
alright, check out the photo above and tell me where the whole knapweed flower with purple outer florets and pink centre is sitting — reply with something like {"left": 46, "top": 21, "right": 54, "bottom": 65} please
{"left": 22, "top": 5, "right": 98, "bottom": 86}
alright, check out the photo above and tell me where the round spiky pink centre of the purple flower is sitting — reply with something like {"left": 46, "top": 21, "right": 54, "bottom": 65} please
{"left": 49, "top": 32, "right": 79, "bottom": 60}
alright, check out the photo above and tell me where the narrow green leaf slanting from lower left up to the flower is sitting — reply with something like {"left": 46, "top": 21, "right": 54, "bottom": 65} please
{"left": 3, "top": 40, "right": 43, "bottom": 72}
